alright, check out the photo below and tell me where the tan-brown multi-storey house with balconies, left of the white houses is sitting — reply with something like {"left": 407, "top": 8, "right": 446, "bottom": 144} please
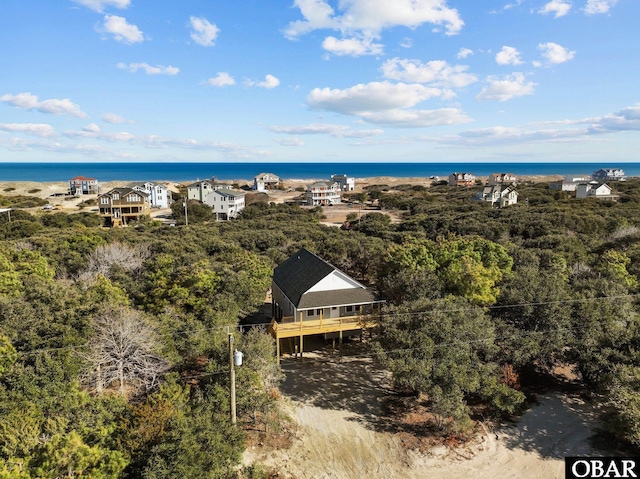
{"left": 98, "top": 188, "right": 151, "bottom": 227}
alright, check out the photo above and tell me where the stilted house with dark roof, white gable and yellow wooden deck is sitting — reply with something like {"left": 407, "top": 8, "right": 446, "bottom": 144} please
{"left": 269, "top": 248, "right": 384, "bottom": 361}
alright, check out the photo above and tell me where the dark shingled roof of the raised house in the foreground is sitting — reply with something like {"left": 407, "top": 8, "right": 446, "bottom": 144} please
{"left": 273, "top": 248, "right": 375, "bottom": 309}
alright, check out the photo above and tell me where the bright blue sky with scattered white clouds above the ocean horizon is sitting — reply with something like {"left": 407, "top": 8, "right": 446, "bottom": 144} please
{"left": 0, "top": 0, "right": 640, "bottom": 164}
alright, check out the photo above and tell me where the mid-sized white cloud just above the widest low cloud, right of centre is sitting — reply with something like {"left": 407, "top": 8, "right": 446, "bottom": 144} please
{"left": 381, "top": 58, "right": 478, "bottom": 88}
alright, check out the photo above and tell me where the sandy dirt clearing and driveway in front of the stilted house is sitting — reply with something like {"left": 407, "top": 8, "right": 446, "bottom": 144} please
{"left": 245, "top": 346, "right": 596, "bottom": 479}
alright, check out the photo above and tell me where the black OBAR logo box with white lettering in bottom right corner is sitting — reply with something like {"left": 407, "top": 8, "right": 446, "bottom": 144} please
{"left": 564, "top": 457, "right": 640, "bottom": 479}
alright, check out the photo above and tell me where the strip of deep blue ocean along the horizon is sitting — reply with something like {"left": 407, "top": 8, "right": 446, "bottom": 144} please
{"left": 0, "top": 163, "right": 640, "bottom": 182}
